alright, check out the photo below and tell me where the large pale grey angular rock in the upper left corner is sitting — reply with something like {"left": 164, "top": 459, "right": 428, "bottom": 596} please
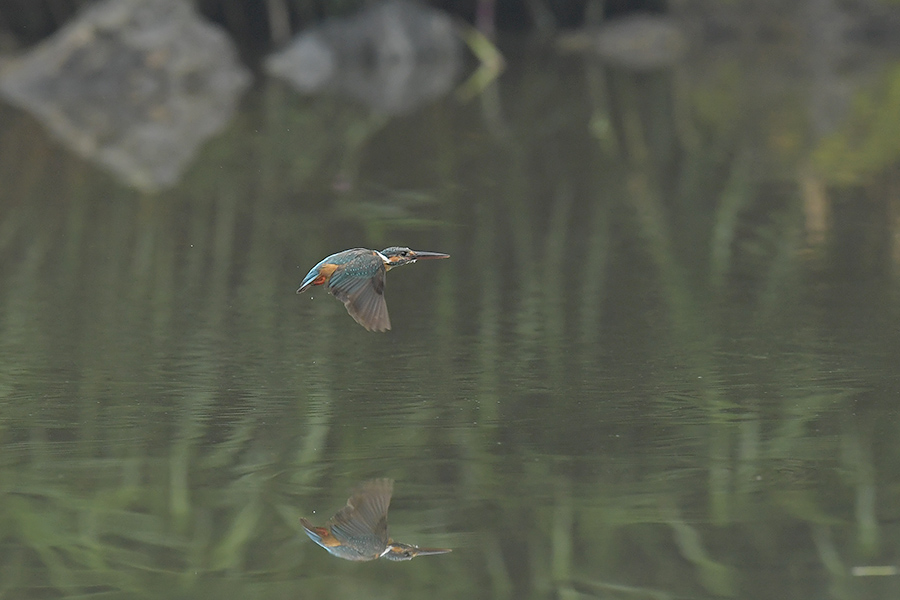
{"left": 0, "top": 0, "right": 250, "bottom": 191}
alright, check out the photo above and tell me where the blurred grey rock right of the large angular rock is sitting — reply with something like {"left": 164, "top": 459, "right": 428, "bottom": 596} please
{"left": 265, "top": 0, "right": 462, "bottom": 114}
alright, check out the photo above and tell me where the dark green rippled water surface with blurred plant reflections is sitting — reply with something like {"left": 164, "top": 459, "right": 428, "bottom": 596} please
{"left": 0, "top": 36, "right": 900, "bottom": 600}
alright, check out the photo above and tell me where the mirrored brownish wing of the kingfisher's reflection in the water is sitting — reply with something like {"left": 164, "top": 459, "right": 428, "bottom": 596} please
{"left": 329, "top": 479, "right": 394, "bottom": 549}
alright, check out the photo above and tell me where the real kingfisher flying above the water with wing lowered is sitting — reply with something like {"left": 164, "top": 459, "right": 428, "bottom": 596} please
{"left": 297, "top": 246, "right": 450, "bottom": 331}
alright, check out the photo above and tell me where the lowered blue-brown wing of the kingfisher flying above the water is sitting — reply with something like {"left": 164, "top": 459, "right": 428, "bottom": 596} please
{"left": 328, "top": 254, "right": 391, "bottom": 331}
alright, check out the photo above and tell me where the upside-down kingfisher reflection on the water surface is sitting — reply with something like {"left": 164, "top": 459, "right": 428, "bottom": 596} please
{"left": 300, "top": 479, "right": 452, "bottom": 562}
